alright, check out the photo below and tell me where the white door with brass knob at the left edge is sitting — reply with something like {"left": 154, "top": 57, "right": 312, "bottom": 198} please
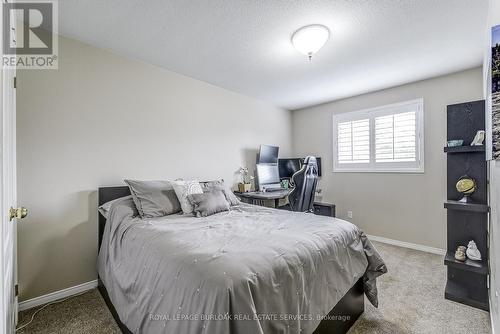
{"left": 0, "top": 1, "right": 19, "bottom": 334}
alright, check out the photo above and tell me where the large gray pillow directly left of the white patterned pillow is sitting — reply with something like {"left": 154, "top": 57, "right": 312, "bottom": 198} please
{"left": 125, "top": 180, "right": 181, "bottom": 218}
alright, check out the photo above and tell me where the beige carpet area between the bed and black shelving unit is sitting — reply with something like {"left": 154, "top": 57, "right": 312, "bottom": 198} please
{"left": 349, "top": 242, "right": 491, "bottom": 334}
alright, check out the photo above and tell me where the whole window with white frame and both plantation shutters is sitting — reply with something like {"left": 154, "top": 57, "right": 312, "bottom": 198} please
{"left": 333, "top": 99, "right": 424, "bottom": 173}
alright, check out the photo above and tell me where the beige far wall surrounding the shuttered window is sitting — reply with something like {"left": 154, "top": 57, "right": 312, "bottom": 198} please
{"left": 292, "top": 68, "right": 482, "bottom": 249}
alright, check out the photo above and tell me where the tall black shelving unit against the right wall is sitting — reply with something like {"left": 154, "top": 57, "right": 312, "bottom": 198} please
{"left": 444, "top": 101, "right": 489, "bottom": 311}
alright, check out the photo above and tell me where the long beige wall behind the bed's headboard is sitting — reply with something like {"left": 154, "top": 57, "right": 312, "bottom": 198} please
{"left": 17, "top": 38, "right": 291, "bottom": 300}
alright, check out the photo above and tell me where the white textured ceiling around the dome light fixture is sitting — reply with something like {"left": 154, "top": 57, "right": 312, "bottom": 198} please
{"left": 59, "top": 0, "right": 488, "bottom": 109}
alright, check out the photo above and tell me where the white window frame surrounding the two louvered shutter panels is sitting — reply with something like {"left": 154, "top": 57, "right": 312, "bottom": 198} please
{"left": 332, "top": 98, "right": 425, "bottom": 173}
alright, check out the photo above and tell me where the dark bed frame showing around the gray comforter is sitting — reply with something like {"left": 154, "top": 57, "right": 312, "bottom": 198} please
{"left": 98, "top": 186, "right": 365, "bottom": 334}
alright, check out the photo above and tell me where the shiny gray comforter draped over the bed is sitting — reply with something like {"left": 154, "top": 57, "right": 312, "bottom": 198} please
{"left": 98, "top": 199, "right": 386, "bottom": 334}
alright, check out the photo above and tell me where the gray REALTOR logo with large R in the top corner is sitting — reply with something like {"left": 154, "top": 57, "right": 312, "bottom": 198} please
{"left": 2, "top": 0, "right": 58, "bottom": 69}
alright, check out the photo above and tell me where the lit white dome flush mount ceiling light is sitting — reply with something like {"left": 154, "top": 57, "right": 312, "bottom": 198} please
{"left": 292, "top": 24, "right": 330, "bottom": 60}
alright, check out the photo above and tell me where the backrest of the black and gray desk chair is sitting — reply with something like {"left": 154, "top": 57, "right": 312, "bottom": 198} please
{"left": 288, "top": 156, "right": 318, "bottom": 212}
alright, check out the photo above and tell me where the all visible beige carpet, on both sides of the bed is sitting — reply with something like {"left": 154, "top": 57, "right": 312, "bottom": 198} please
{"left": 18, "top": 243, "right": 491, "bottom": 334}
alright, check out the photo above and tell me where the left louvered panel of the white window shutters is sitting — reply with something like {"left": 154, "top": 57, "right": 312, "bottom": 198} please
{"left": 338, "top": 119, "right": 370, "bottom": 163}
